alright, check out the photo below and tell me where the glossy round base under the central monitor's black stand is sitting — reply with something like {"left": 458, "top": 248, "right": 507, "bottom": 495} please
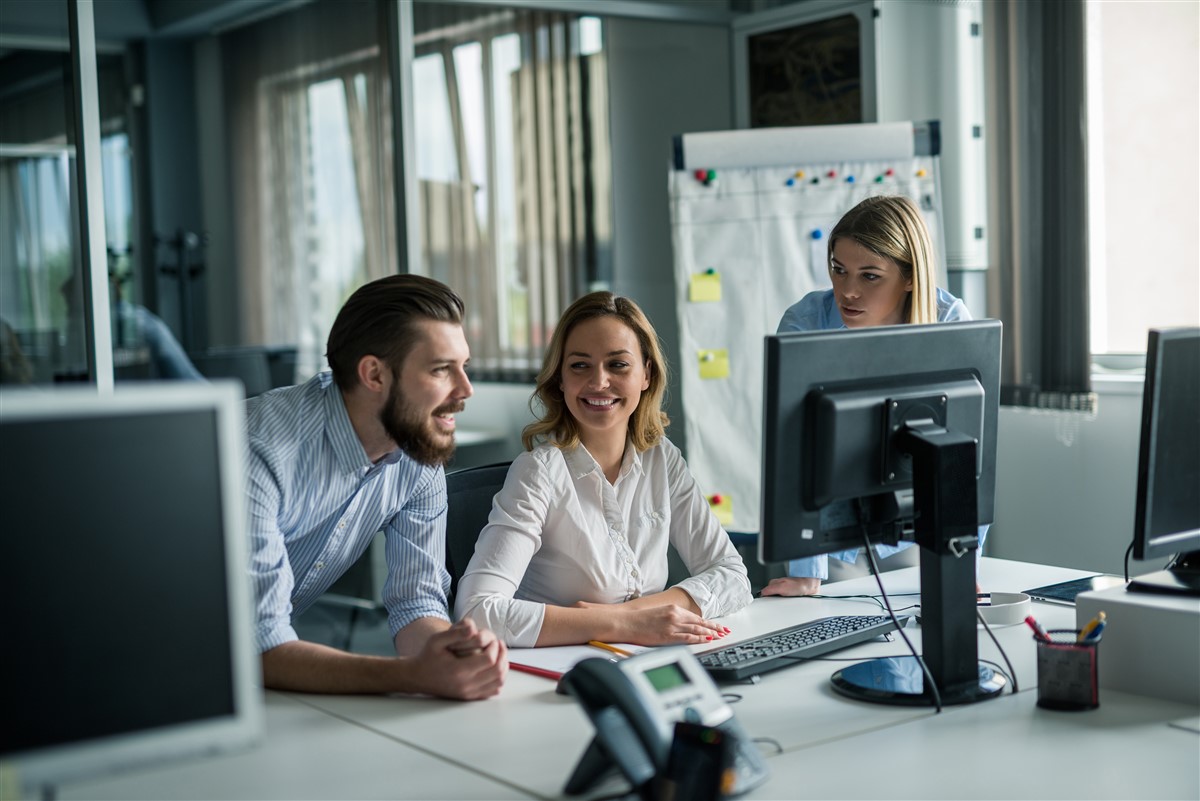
{"left": 830, "top": 656, "right": 1008, "bottom": 706}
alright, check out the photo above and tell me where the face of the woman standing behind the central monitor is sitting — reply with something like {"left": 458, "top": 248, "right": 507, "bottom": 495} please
{"left": 829, "top": 237, "right": 912, "bottom": 329}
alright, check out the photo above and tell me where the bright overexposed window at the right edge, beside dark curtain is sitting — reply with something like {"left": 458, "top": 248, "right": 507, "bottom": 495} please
{"left": 1087, "top": 0, "right": 1200, "bottom": 355}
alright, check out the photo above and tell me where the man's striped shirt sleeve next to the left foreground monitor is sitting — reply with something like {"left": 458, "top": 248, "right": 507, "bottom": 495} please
{"left": 246, "top": 442, "right": 300, "bottom": 652}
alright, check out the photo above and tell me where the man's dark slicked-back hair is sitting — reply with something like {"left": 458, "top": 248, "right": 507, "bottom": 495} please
{"left": 325, "top": 275, "right": 463, "bottom": 392}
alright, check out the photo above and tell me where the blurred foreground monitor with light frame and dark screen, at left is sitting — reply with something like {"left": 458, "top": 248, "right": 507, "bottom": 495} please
{"left": 0, "top": 383, "right": 263, "bottom": 795}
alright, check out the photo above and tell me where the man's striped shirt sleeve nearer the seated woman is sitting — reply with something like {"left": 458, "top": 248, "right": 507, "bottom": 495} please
{"left": 383, "top": 469, "right": 450, "bottom": 637}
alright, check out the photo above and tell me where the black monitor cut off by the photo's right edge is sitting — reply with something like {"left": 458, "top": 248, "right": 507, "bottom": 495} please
{"left": 1129, "top": 329, "right": 1200, "bottom": 595}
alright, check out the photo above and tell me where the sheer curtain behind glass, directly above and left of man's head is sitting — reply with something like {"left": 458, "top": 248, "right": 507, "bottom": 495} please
{"left": 222, "top": 0, "right": 397, "bottom": 380}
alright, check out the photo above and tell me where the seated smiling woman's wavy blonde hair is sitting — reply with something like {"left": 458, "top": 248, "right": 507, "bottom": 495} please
{"left": 521, "top": 293, "right": 671, "bottom": 452}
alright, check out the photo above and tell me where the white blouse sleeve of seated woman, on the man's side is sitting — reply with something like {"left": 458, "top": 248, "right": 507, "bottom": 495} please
{"left": 455, "top": 453, "right": 550, "bottom": 648}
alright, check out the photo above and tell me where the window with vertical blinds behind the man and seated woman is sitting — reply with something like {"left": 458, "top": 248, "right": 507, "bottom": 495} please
{"left": 413, "top": 4, "right": 611, "bottom": 381}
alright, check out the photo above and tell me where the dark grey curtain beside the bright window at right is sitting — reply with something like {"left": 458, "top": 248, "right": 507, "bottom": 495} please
{"left": 984, "top": 0, "right": 1096, "bottom": 411}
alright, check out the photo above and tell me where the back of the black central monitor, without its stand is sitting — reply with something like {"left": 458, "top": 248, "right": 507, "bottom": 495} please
{"left": 760, "top": 320, "right": 1001, "bottom": 562}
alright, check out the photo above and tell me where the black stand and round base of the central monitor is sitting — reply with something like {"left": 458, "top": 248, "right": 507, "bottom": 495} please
{"left": 832, "top": 422, "right": 1008, "bottom": 706}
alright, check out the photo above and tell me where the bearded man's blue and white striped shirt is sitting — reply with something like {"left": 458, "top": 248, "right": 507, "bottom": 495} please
{"left": 246, "top": 373, "right": 450, "bottom": 651}
